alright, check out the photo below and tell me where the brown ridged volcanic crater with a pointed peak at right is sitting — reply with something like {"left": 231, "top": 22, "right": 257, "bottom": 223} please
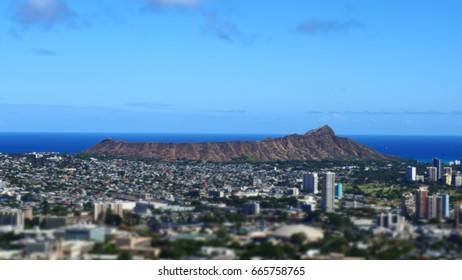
{"left": 82, "top": 125, "right": 391, "bottom": 162}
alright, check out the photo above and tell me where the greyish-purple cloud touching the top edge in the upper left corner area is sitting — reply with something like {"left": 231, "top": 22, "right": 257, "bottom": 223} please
{"left": 13, "top": 0, "right": 76, "bottom": 30}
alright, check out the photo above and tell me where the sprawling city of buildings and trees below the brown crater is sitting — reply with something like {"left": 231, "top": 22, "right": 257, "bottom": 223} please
{"left": 0, "top": 153, "right": 462, "bottom": 260}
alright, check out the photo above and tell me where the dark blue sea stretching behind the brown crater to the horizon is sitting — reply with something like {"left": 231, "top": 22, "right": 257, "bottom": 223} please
{"left": 0, "top": 133, "right": 462, "bottom": 162}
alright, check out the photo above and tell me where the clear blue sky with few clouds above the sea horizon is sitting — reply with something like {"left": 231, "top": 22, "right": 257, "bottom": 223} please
{"left": 0, "top": 0, "right": 462, "bottom": 135}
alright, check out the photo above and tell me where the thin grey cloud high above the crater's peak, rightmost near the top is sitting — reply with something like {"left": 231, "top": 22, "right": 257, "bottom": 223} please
{"left": 296, "top": 18, "right": 365, "bottom": 35}
